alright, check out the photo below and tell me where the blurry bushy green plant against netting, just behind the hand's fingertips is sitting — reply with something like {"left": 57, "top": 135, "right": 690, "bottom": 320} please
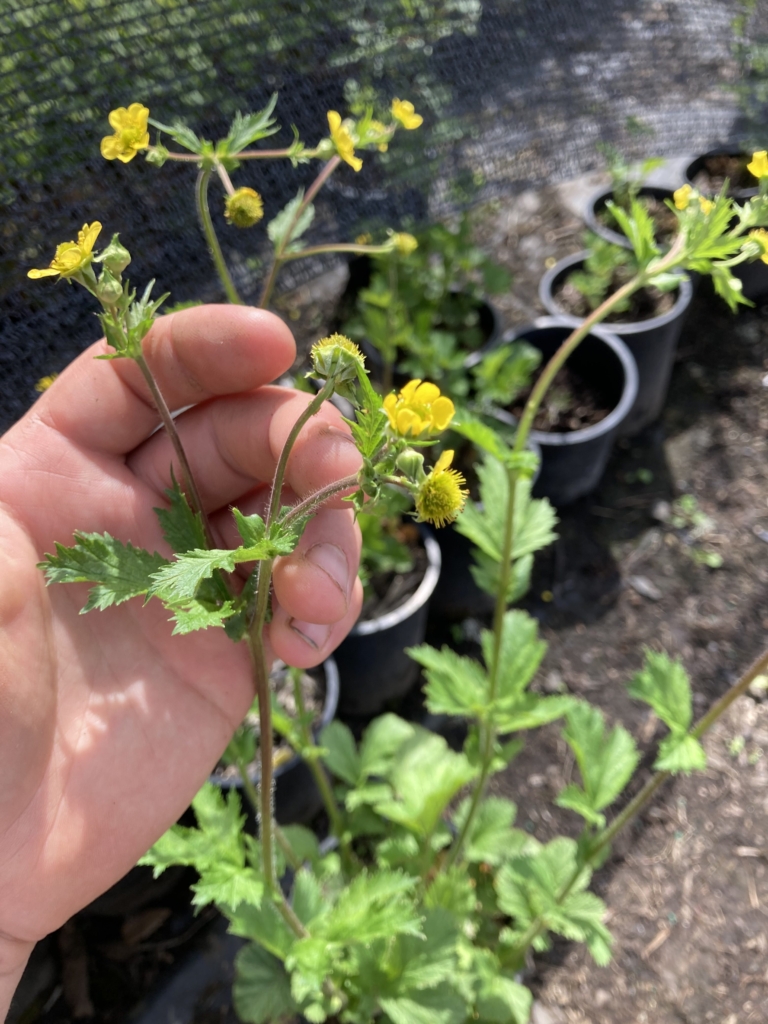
{"left": 340, "top": 214, "right": 510, "bottom": 400}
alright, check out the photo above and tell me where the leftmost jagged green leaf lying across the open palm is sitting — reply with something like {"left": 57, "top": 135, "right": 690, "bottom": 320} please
{"left": 40, "top": 532, "right": 169, "bottom": 614}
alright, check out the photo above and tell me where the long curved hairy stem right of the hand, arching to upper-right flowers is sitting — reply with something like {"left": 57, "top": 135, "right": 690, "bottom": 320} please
{"left": 445, "top": 236, "right": 684, "bottom": 872}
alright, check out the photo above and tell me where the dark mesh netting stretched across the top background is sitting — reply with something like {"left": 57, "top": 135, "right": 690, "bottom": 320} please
{"left": 0, "top": 0, "right": 768, "bottom": 428}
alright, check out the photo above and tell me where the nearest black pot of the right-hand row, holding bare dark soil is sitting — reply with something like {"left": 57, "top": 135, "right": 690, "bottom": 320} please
{"left": 499, "top": 316, "right": 638, "bottom": 506}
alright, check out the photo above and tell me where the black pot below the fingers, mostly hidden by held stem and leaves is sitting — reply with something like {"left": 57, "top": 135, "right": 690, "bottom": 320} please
{"left": 211, "top": 657, "right": 339, "bottom": 833}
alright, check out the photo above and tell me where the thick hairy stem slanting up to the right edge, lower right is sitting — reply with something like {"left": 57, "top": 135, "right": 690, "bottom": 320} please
{"left": 505, "top": 638, "right": 768, "bottom": 965}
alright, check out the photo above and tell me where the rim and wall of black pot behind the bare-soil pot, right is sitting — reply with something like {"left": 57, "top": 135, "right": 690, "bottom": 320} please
{"left": 539, "top": 251, "right": 693, "bottom": 437}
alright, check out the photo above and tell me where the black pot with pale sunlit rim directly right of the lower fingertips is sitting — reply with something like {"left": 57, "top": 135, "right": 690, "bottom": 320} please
{"left": 334, "top": 530, "right": 441, "bottom": 718}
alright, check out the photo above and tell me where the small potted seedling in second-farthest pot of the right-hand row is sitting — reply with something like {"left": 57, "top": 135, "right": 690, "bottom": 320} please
{"left": 585, "top": 146, "right": 678, "bottom": 249}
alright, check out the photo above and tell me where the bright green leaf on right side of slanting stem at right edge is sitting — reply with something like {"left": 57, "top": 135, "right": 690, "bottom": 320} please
{"left": 629, "top": 650, "right": 707, "bottom": 772}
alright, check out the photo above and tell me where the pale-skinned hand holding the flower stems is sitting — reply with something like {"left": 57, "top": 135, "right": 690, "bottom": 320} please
{"left": 0, "top": 306, "right": 361, "bottom": 1020}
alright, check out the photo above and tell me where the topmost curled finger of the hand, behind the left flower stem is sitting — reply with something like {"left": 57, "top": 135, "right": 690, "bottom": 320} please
{"left": 33, "top": 305, "right": 296, "bottom": 455}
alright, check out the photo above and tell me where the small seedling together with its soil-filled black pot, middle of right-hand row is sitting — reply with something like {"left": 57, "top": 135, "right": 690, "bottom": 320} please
{"left": 539, "top": 230, "right": 693, "bottom": 436}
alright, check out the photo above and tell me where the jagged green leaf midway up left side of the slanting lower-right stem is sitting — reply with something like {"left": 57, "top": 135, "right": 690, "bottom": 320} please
{"left": 555, "top": 701, "right": 640, "bottom": 828}
